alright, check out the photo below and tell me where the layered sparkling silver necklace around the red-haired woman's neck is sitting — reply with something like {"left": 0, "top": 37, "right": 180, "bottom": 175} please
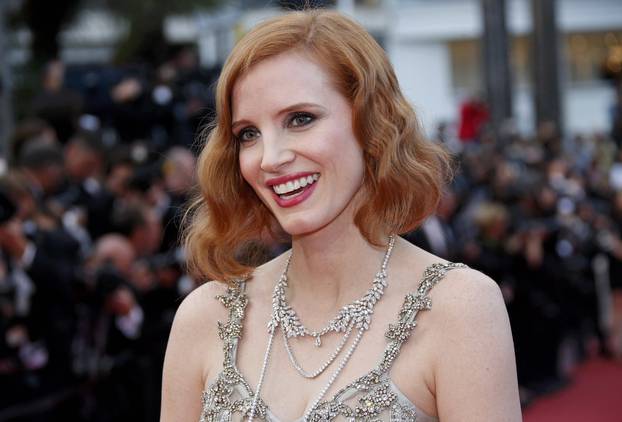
{"left": 248, "top": 235, "right": 395, "bottom": 422}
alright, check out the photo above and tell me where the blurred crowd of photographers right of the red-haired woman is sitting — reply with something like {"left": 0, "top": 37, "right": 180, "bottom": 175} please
{"left": 407, "top": 100, "right": 622, "bottom": 404}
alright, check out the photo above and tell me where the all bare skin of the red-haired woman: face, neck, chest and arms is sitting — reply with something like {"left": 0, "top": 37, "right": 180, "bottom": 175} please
{"left": 161, "top": 52, "right": 521, "bottom": 422}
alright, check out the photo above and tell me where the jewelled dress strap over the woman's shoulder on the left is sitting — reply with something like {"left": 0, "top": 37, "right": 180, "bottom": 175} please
{"left": 216, "top": 280, "right": 248, "bottom": 369}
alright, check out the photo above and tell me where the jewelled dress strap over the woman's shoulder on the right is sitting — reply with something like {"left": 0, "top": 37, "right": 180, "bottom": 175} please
{"left": 378, "top": 262, "right": 467, "bottom": 373}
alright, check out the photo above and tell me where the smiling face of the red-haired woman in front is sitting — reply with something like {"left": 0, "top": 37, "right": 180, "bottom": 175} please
{"left": 232, "top": 52, "right": 364, "bottom": 236}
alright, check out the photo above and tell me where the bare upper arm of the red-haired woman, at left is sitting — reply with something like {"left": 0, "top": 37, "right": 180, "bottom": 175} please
{"left": 160, "top": 283, "right": 222, "bottom": 422}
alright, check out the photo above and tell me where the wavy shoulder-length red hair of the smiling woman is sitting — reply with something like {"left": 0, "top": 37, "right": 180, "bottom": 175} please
{"left": 184, "top": 10, "right": 450, "bottom": 280}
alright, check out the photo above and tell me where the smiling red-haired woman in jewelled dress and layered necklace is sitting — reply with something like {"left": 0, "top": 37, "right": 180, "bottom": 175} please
{"left": 161, "top": 11, "right": 520, "bottom": 422}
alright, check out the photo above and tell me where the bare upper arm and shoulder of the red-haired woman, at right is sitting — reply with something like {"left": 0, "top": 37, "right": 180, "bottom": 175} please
{"left": 432, "top": 269, "right": 522, "bottom": 422}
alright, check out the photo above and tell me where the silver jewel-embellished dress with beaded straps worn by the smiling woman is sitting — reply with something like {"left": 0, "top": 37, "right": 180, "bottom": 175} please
{"left": 200, "top": 263, "right": 465, "bottom": 422}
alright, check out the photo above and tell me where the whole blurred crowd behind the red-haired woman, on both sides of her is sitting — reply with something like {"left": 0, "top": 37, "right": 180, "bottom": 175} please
{"left": 0, "top": 49, "right": 622, "bottom": 422}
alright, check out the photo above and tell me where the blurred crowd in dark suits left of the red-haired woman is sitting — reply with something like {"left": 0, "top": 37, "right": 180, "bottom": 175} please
{"left": 0, "top": 49, "right": 213, "bottom": 421}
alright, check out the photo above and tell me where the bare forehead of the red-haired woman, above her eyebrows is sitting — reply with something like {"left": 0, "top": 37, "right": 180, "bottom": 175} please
{"left": 231, "top": 52, "right": 339, "bottom": 120}
